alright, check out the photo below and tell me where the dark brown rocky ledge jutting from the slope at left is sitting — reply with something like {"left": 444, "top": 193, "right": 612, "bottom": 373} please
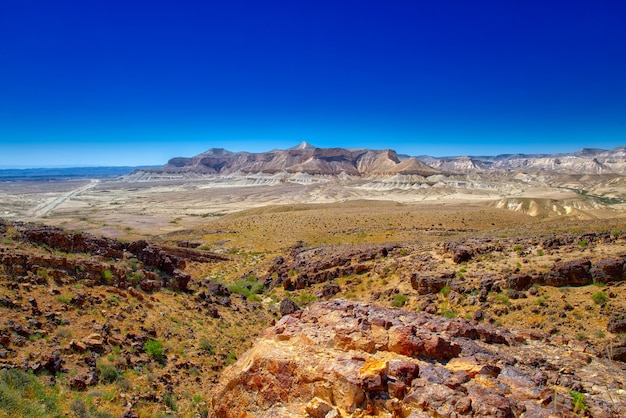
{"left": 0, "top": 222, "right": 228, "bottom": 291}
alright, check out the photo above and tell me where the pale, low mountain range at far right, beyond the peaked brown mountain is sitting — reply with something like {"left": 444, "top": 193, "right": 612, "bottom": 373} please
{"left": 417, "top": 147, "right": 626, "bottom": 174}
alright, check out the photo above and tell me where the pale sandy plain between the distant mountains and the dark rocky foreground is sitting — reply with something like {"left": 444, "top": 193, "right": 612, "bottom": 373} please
{"left": 0, "top": 174, "right": 626, "bottom": 245}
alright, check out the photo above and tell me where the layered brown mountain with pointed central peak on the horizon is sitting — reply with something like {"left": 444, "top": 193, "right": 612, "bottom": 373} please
{"left": 142, "top": 142, "right": 440, "bottom": 176}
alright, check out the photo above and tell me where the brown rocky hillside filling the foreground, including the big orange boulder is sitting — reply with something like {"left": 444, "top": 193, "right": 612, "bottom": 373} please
{"left": 0, "top": 216, "right": 626, "bottom": 418}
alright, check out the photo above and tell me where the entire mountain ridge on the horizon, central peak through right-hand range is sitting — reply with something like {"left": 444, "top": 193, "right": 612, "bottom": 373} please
{"left": 140, "top": 142, "right": 626, "bottom": 177}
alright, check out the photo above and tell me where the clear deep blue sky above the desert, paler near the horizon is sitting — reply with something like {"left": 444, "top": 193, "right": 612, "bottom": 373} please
{"left": 0, "top": 0, "right": 626, "bottom": 167}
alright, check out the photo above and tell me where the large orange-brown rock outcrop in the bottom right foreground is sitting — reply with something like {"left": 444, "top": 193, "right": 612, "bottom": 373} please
{"left": 212, "top": 299, "right": 626, "bottom": 417}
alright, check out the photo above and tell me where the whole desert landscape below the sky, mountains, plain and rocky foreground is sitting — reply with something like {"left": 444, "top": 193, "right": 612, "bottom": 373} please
{"left": 0, "top": 143, "right": 626, "bottom": 417}
